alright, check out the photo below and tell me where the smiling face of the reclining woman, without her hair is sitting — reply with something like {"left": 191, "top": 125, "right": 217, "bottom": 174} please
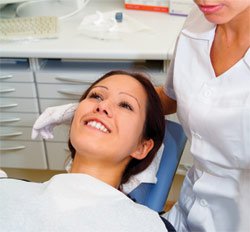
{"left": 70, "top": 75, "right": 151, "bottom": 168}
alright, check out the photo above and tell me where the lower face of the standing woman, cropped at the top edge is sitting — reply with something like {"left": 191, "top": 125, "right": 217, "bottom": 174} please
{"left": 194, "top": 0, "right": 250, "bottom": 24}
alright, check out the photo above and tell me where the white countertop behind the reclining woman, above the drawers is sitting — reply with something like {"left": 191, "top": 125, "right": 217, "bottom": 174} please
{"left": 0, "top": 0, "right": 185, "bottom": 60}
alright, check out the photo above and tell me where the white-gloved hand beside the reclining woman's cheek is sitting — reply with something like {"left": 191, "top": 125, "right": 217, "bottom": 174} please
{"left": 31, "top": 103, "right": 79, "bottom": 139}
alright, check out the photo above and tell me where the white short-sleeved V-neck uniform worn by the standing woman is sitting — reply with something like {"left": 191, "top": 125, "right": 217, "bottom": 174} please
{"left": 165, "top": 5, "right": 250, "bottom": 232}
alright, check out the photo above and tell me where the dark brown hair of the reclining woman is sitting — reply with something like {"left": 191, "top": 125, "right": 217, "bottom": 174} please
{"left": 68, "top": 70, "right": 165, "bottom": 184}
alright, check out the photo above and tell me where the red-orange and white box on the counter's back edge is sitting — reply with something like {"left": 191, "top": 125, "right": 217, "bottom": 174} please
{"left": 125, "top": 0, "right": 169, "bottom": 13}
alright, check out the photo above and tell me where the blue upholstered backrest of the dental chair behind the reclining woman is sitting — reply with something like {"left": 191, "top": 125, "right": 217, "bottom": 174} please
{"left": 129, "top": 120, "right": 186, "bottom": 212}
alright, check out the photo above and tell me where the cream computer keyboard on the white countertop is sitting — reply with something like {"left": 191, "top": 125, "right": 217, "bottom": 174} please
{"left": 0, "top": 16, "right": 58, "bottom": 40}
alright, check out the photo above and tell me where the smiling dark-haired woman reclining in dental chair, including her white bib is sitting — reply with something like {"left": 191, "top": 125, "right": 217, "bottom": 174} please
{"left": 0, "top": 71, "right": 174, "bottom": 232}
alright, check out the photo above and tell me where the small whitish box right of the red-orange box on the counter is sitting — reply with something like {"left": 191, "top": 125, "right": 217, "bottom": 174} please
{"left": 169, "top": 0, "right": 195, "bottom": 16}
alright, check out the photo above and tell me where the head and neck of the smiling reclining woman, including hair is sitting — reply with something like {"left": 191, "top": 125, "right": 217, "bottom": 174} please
{"left": 69, "top": 71, "right": 164, "bottom": 187}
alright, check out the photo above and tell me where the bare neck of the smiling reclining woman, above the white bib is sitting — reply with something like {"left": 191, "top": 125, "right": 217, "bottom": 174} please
{"left": 70, "top": 155, "right": 123, "bottom": 189}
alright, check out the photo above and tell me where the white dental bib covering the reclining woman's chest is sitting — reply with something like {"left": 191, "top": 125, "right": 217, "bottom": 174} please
{"left": 0, "top": 174, "right": 166, "bottom": 232}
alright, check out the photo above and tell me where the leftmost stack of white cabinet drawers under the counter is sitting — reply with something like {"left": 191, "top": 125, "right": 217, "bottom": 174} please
{"left": 0, "top": 59, "right": 47, "bottom": 169}
